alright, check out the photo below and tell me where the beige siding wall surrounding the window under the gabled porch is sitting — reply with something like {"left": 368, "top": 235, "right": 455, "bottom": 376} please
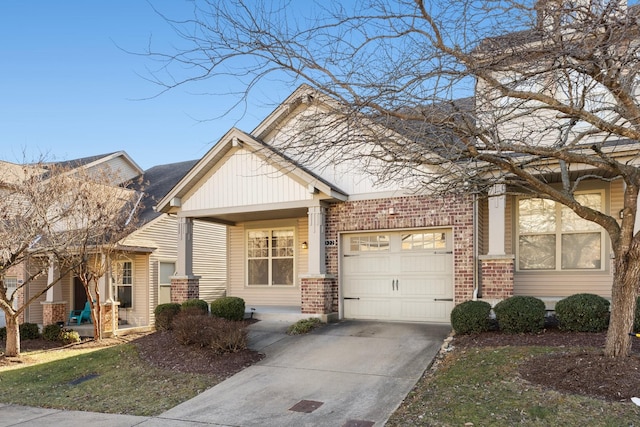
{"left": 228, "top": 217, "right": 308, "bottom": 307}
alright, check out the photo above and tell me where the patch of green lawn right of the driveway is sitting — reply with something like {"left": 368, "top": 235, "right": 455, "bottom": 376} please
{"left": 387, "top": 347, "right": 640, "bottom": 426}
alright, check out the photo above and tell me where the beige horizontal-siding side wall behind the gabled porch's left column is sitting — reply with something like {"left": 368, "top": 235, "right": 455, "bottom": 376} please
{"left": 126, "top": 215, "right": 227, "bottom": 322}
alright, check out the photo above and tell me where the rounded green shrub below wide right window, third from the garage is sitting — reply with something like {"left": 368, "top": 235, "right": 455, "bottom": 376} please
{"left": 556, "top": 294, "right": 610, "bottom": 332}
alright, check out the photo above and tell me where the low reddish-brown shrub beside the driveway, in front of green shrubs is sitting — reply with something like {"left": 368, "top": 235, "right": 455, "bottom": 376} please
{"left": 173, "top": 312, "right": 247, "bottom": 354}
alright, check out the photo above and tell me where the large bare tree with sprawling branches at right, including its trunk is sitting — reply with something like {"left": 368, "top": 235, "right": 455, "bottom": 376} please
{"left": 148, "top": 0, "right": 640, "bottom": 357}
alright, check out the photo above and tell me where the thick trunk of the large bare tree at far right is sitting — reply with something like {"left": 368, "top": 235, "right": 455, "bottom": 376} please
{"left": 604, "top": 257, "right": 640, "bottom": 357}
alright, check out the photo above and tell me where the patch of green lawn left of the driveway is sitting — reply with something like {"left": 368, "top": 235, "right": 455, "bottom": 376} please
{"left": 0, "top": 344, "right": 218, "bottom": 416}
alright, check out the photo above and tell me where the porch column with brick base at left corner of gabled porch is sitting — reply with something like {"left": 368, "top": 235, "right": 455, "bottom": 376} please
{"left": 171, "top": 217, "right": 200, "bottom": 303}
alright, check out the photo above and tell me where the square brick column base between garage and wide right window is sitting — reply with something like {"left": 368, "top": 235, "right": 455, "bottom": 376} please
{"left": 480, "top": 255, "right": 515, "bottom": 300}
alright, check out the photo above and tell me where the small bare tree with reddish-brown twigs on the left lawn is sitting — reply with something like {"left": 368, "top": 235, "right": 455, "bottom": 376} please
{"left": 0, "top": 161, "right": 138, "bottom": 356}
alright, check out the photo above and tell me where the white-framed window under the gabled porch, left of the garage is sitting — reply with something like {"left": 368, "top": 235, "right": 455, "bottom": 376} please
{"left": 247, "top": 228, "right": 295, "bottom": 286}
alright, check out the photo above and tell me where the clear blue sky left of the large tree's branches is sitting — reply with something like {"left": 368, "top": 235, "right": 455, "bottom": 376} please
{"left": 0, "top": 0, "right": 291, "bottom": 169}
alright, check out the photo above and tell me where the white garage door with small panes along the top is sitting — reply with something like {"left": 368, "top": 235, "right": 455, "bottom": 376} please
{"left": 341, "top": 229, "right": 453, "bottom": 322}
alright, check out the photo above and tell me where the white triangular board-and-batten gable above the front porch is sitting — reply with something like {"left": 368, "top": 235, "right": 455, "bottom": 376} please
{"left": 182, "top": 149, "right": 313, "bottom": 212}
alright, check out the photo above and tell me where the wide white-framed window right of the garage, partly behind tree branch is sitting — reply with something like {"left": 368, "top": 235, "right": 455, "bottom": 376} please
{"left": 516, "top": 191, "right": 605, "bottom": 271}
